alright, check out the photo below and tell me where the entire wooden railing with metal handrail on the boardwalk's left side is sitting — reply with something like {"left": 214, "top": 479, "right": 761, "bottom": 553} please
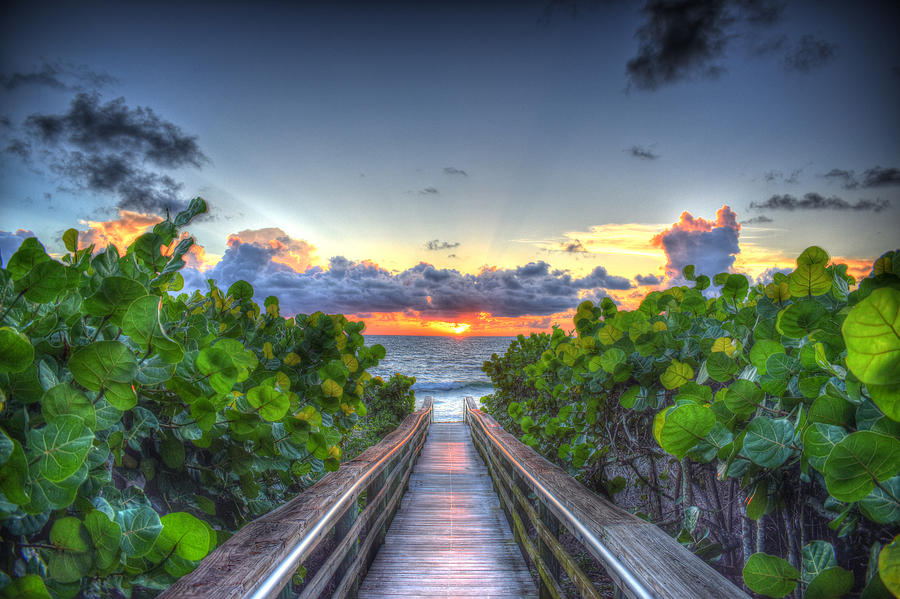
{"left": 160, "top": 398, "right": 433, "bottom": 599}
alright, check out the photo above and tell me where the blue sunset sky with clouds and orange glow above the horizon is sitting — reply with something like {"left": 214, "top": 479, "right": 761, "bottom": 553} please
{"left": 0, "top": 0, "right": 900, "bottom": 335}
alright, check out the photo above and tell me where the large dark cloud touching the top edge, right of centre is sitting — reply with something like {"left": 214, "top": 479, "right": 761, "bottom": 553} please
{"left": 625, "top": 0, "right": 730, "bottom": 90}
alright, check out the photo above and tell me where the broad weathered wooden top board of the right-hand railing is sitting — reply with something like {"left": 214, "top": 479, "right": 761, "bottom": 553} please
{"left": 465, "top": 398, "right": 749, "bottom": 599}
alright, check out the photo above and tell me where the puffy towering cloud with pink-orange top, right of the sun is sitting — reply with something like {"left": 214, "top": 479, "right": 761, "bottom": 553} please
{"left": 651, "top": 206, "right": 741, "bottom": 278}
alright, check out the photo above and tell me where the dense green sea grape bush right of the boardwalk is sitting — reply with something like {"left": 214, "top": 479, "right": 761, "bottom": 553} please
{"left": 484, "top": 247, "right": 900, "bottom": 599}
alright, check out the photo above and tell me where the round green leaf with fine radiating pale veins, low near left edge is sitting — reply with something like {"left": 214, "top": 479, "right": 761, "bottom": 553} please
{"left": 28, "top": 414, "right": 94, "bottom": 482}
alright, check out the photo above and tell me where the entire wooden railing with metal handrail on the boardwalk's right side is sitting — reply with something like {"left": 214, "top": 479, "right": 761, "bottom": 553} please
{"left": 465, "top": 397, "right": 749, "bottom": 599}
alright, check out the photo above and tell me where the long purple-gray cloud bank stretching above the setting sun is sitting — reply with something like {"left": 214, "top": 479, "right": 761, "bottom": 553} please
{"left": 183, "top": 243, "right": 631, "bottom": 320}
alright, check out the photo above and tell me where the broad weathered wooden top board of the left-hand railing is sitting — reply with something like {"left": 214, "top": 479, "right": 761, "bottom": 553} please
{"left": 160, "top": 401, "right": 432, "bottom": 599}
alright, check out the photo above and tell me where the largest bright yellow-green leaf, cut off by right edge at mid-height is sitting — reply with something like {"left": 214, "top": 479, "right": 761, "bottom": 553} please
{"left": 841, "top": 287, "right": 900, "bottom": 386}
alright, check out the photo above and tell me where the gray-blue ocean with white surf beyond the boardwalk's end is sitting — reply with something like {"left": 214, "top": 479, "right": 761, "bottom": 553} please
{"left": 366, "top": 335, "right": 514, "bottom": 421}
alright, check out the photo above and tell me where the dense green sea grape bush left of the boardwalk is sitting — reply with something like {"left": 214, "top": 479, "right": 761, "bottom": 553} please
{"left": 0, "top": 198, "right": 404, "bottom": 598}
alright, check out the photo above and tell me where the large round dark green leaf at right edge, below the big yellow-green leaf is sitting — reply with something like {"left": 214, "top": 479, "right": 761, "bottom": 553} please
{"left": 824, "top": 431, "right": 900, "bottom": 502}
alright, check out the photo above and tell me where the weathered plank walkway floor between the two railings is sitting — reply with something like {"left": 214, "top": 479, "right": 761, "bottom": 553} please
{"left": 359, "top": 422, "right": 537, "bottom": 599}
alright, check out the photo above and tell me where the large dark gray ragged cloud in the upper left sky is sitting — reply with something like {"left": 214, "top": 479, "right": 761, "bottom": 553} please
{"left": 6, "top": 93, "right": 208, "bottom": 215}
